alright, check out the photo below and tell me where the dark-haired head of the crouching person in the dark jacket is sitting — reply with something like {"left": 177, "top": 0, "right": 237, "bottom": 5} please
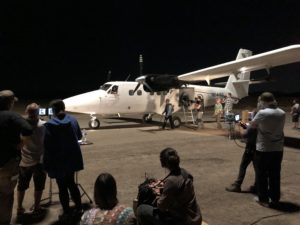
{"left": 159, "top": 148, "right": 180, "bottom": 171}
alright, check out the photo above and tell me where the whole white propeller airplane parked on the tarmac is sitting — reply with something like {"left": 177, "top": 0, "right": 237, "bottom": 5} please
{"left": 63, "top": 44, "right": 300, "bottom": 129}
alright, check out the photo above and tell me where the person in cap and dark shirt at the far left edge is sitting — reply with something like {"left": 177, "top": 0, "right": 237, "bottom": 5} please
{"left": 0, "top": 90, "right": 32, "bottom": 225}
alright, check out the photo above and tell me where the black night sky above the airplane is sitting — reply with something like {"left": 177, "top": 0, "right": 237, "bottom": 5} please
{"left": 0, "top": 0, "right": 300, "bottom": 98}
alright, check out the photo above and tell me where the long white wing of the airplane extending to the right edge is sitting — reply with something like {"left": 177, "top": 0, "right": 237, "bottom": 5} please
{"left": 178, "top": 45, "right": 300, "bottom": 83}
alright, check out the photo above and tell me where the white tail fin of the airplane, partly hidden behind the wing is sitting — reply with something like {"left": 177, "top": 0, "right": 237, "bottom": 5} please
{"left": 225, "top": 49, "right": 252, "bottom": 99}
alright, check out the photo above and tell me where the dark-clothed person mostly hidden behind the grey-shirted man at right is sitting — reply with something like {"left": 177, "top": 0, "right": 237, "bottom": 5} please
{"left": 225, "top": 109, "right": 257, "bottom": 193}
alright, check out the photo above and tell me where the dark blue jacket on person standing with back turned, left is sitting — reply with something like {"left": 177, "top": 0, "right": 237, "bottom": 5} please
{"left": 44, "top": 115, "right": 83, "bottom": 178}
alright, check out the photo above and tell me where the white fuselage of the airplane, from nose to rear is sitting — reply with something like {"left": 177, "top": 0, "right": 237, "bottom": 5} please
{"left": 64, "top": 81, "right": 227, "bottom": 115}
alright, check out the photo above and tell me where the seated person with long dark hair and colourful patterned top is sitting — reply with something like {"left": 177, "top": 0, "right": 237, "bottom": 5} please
{"left": 80, "top": 173, "right": 136, "bottom": 225}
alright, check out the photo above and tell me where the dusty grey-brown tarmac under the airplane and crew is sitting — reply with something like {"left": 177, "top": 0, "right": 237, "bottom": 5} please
{"left": 12, "top": 100, "right": 300, "bottom": 225}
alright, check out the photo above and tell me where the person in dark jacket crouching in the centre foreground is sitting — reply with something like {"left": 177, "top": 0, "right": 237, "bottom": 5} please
{"left": 137, "top": 148, "right": 202, "bottom": 225}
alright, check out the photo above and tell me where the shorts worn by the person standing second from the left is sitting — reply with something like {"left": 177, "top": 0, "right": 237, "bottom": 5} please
{"left": 18, "top": 163, "right": 46, "bottom": 191}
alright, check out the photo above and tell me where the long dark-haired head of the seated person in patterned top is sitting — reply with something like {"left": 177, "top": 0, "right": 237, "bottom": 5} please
{"left": 94, "top": 173, "right": 118, "bottom": 210}
